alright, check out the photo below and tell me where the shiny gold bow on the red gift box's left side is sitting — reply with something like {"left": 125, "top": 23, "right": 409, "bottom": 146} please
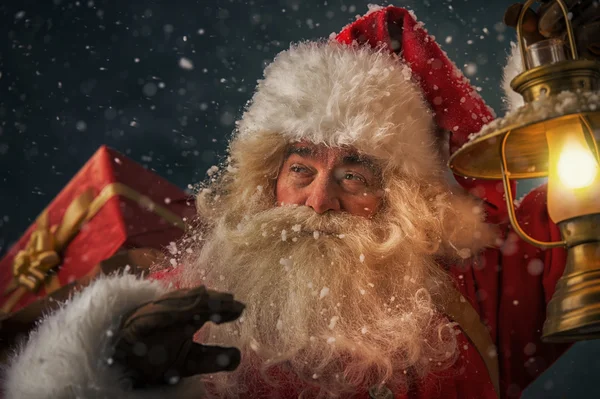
{"left": 4, "top": 189, "right": 94, "bottom": 295}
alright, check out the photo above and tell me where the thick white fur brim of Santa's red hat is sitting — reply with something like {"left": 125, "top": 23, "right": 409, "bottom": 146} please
{"left": 238, "top": 41, "right": 440, "bottom": 176}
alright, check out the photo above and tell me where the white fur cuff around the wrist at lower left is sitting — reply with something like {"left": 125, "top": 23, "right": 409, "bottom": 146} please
{"left": 3, "top": 275, "right": 204, "bottom": 399}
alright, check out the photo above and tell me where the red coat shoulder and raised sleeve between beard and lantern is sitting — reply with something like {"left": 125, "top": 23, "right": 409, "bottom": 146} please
{"left": 452, "top": 186, "right": 570, "bottom": 398}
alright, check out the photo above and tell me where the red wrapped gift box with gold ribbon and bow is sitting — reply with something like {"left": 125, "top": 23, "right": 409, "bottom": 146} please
{"left": 0, "top": 146, "right": 195, "bottom": 314}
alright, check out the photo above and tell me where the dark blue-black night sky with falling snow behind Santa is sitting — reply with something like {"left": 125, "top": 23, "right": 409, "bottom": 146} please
{"left": 0, "top": 0, "right": 600, "bottom": 398}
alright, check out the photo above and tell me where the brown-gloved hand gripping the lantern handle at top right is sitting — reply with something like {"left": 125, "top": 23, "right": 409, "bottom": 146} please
{"left": 504, "top": 0, "right": 600, "bottom": 60}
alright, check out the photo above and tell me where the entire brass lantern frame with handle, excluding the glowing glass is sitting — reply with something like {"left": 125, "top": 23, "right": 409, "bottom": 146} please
{"left": 449, "top": 1, "right": 600, "bottom": 342}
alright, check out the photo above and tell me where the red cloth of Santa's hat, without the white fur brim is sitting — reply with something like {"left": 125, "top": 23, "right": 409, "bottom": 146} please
{"left": 336, "top": 6, "right": 508, "bottom": 223}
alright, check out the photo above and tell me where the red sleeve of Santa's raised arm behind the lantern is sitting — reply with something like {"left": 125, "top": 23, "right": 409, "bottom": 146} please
{"left": 498, "top": 186, "right": 570, "bottom": 396}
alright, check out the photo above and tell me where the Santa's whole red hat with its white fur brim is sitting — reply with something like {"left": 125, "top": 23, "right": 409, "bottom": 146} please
{"left": 238, "top": 6, "right": 506, "bottom": 222}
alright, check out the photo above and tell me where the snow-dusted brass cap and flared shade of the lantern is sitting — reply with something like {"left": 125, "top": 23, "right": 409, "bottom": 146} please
{"left": 450, "top": 60, "right": 600, "bottom": 179}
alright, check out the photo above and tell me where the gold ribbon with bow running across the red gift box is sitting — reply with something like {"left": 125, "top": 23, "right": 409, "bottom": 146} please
{"left": 0, "top": 183, "right": 185, "bottom": 313}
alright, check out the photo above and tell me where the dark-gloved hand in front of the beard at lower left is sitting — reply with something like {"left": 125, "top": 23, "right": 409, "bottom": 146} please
{"left": 113, "top": 287, "right": 244, "bottom": 387}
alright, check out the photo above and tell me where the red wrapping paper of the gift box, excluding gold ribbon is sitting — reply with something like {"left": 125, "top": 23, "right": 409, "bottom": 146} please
{"left": 0, "top": 146, "right": 195, "bottom": 311}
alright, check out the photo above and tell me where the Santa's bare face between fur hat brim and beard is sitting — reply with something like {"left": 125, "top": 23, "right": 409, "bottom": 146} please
{"left": 275, "top": 142, "right": 383, "bottom": 218}
